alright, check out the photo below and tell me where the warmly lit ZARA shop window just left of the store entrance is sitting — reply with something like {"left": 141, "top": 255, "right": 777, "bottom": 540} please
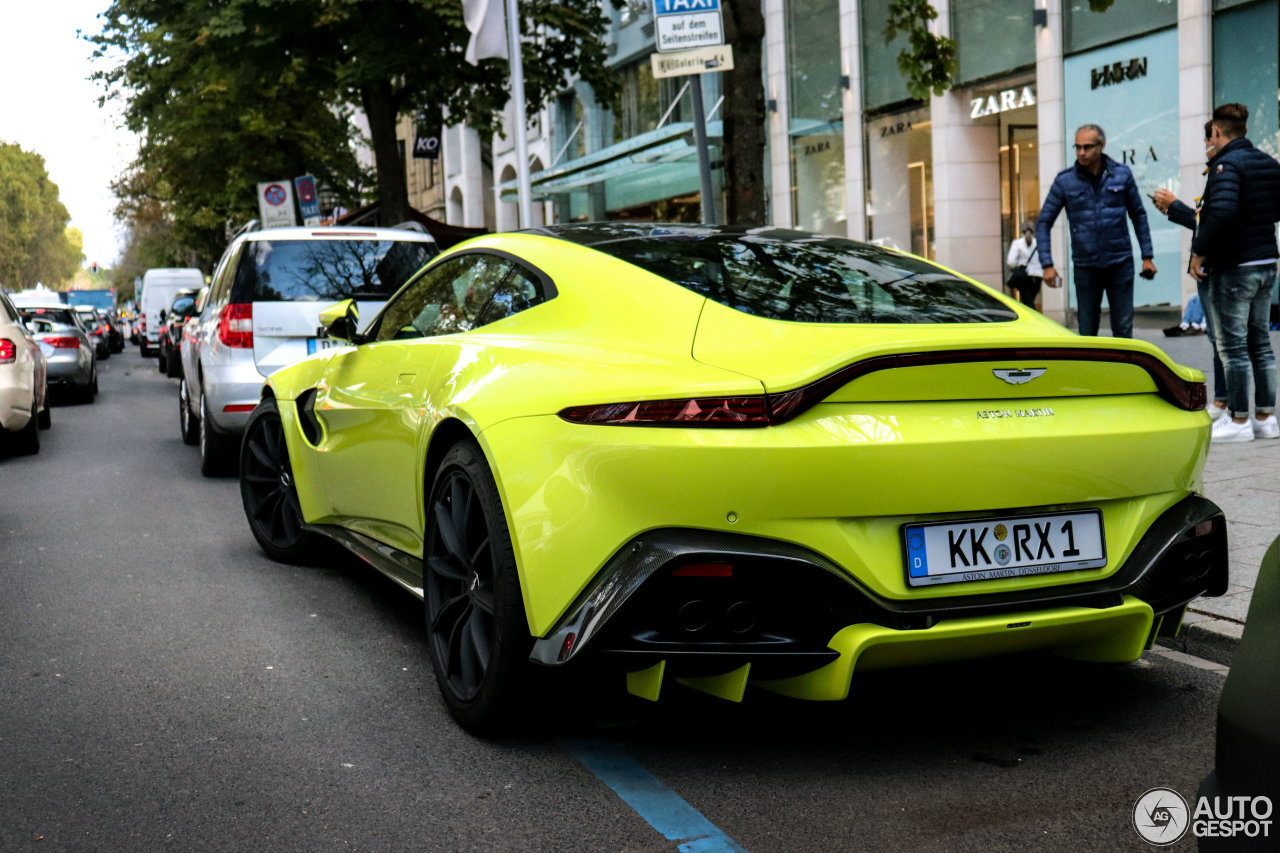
{"left": 867, "top": 109, "right": 936, "bottom": 260}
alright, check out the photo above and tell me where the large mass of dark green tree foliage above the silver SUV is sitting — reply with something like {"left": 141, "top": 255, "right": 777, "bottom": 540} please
{"left": 91, "top": 0, "right": 618, "bottom": 253}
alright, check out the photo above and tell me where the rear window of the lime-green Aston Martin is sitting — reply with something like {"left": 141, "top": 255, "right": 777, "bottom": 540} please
{"left": 593, "top": 234, "right": 1018, "bottom": 323}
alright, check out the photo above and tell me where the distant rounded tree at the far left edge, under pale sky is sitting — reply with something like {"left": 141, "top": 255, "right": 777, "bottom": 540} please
{"left": 0, "top": 142, "right": 84, "bottom": 291}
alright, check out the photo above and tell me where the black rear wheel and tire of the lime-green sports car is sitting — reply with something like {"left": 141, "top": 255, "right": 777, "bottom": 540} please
{"left": 422, "top": 441, "right": 532, "bottom": 734}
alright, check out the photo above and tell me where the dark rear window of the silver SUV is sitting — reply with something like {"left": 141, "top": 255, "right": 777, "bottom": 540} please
{"left": 232, "top": 240, "right": 436, "bottom": 302}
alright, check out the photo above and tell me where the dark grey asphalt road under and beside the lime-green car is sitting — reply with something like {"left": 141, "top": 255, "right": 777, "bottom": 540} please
{"left": 0, "top": 347, "right": 1222, "bottom": 853}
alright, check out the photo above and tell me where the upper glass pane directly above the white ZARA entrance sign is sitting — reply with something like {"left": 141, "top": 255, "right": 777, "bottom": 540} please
{"left": 951, "top": 0, "right": 1036, "bottom": 82}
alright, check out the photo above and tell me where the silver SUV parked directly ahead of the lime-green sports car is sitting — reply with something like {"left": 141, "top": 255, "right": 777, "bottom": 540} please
{"left": 178, "top": 227, "right": 438, "bottom": 476}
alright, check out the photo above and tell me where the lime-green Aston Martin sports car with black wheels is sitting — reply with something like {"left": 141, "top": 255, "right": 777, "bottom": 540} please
{"left": 241, "top": 223, "right": 1228, "bottom": 729}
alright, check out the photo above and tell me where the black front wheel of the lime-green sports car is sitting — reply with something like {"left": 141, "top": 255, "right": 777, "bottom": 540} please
{"left": 239, "top": 398, "right": 320, "bottom": 562}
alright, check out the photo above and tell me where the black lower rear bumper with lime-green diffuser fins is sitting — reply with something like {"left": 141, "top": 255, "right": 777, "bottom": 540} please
{"left": 531, "top": 494, "right": 1228, "bottom": 699}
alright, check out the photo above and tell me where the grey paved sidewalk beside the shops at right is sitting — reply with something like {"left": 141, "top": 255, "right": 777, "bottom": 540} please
{"left": 1126, "top": 318, "right": 1280, "bottom": 663}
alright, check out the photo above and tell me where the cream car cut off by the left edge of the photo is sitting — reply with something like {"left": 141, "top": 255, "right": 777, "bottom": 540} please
{"left": 0, "top": 291, "right": 51, "bottom": 453}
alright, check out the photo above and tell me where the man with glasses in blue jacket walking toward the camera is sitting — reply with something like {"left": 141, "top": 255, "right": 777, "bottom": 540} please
{"left": 1036, "top": 124, "right": 1156, "bottom": 338}
